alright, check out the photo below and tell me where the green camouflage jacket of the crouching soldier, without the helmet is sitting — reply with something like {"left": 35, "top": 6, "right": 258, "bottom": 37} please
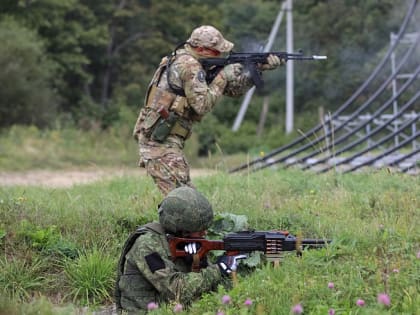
{"left": 116, "top": 223, "right": 222, "bottom": 313}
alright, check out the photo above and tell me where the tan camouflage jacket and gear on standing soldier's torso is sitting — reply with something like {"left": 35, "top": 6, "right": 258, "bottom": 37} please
{"left": 133, "top": 46, "right": 252, "bottom": 163}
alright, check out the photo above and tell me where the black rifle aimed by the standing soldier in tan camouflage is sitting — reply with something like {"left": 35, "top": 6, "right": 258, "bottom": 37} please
{"left": 200, "top": 52, "right": 327, "bottom": 89}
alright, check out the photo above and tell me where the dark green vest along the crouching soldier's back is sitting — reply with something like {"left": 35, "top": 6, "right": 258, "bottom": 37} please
{"left": 114, "top": 223, "right": 165, "bottom": 314}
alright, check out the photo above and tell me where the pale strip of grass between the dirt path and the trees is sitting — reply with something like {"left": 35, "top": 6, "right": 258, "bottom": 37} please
{"left": 0, "top": 126, "right": 245, "bottom": 171}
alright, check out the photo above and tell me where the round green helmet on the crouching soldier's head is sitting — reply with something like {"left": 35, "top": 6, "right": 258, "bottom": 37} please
{"left": 159, "top": 186, "right": 213, "bottom": 233}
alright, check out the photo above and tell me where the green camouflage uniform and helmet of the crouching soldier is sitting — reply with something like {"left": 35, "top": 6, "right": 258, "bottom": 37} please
{"left": 115, "top": 186, "right": 222, "bottom": 314}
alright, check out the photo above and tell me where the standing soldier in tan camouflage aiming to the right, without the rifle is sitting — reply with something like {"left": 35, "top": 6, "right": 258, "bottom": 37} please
{"left": 133, "top": 26, "right": 284, "bottom": 195}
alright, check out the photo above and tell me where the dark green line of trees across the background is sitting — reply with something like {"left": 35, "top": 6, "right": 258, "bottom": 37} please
{"left": 0, "top": 0, "right": 405, "bottom": 152}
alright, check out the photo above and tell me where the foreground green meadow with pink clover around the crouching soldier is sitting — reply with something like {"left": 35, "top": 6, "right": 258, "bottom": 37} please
{"left": 0, "top": 169, "right": 420, "bottom": 315}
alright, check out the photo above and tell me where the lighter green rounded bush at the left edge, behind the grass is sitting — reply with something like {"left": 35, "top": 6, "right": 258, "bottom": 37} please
{"left": 0, "top": 18, "right": 58, "bottom": 127}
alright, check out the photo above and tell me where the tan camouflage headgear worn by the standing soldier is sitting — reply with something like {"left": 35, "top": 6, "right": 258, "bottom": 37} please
{"left": 187, "top": 25, "right": 233, "bottom": 53}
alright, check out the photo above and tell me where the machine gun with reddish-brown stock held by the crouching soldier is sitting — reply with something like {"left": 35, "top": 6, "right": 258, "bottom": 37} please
{"left": 168, "top": 231, "right": 331, "bottom": 270}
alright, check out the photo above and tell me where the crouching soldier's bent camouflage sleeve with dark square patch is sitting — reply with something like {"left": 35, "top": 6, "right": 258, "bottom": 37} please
{"left": 127, "top": 234, "right": 222, "bottom": 304}
